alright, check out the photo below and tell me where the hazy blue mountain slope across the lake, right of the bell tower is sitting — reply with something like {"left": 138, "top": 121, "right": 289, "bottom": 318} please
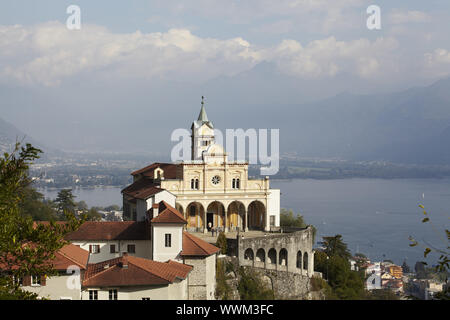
{"left": 220, "top": 75, "right": 450, "bottom": 164}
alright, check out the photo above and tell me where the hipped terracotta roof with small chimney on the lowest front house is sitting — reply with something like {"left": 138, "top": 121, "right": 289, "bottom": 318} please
{"left": 83, "top": 256, "right": 193, "bottom": 287}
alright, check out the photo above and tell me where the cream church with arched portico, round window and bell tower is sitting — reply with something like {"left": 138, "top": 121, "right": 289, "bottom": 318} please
{"left": 122, "top": 97, "right": 280, "bottom": 233}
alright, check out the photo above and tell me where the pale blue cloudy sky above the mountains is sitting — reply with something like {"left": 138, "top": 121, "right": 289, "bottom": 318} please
{"left": 0, "top": 0, "right": 450, "bottom": 154}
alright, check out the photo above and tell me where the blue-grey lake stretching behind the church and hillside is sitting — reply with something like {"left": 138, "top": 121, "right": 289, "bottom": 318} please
{"left": 40, "top": 178, "right": 450, "bottom": 267}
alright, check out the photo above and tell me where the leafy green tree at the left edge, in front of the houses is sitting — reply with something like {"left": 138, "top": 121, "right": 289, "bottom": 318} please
{"left": 0, "top": 143, "right": 82, "bottom": 299}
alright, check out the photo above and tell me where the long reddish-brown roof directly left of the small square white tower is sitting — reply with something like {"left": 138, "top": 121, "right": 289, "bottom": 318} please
{"left": 66, "top": 221, "right": 150, "bottom": 241}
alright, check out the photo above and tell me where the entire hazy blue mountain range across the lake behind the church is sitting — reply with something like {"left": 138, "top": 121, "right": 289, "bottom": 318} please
{"left": 0, "top": 63, "right": 450, "bottom": 164}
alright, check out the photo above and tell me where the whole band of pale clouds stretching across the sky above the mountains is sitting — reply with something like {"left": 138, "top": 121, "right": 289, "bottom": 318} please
{"left": 0, "top": 22, "right": 449, "bottom": 86}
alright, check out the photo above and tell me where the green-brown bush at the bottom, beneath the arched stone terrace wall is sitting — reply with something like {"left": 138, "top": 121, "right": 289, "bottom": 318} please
{"left": 238, "top": 267, "right": 274, "bottom": 300}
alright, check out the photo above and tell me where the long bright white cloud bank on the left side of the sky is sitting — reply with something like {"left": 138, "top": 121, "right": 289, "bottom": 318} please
{"left": 0, "top": 22, "right": 260, "bottom": 86}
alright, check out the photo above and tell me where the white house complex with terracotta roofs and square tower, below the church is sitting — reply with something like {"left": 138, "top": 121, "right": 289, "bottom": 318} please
{"left": 66, "top": 201, "right": 219, "bottom": 300}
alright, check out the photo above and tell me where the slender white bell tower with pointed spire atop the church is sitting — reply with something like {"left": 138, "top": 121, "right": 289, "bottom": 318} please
{"left": 191, "top": 96, "right": 214, "bottom": 160}
